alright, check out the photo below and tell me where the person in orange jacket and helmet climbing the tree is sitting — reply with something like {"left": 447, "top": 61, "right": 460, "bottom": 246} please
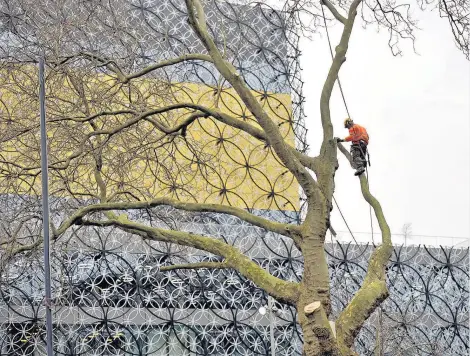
{"left": 336, "top": 118, "right": 369, "bottom": 176}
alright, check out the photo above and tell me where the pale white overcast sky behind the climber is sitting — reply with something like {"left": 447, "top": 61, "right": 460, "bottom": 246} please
{"left": 300, "top": 12, "right": 470, "bottom": 246}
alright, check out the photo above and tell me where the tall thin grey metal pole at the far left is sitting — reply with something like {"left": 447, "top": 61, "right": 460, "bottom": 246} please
{"left": 39, "top": 56, "right": 54, "bottom": 356}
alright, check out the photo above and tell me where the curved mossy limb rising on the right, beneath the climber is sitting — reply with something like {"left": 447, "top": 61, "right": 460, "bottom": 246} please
{"left": 336, "top": 144, "right": 393, "bottom": 352}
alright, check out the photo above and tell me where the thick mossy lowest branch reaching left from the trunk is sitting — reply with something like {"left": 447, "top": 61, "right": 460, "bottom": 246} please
{"left": 82, "top": 215, "right": 299, "bottom": 305}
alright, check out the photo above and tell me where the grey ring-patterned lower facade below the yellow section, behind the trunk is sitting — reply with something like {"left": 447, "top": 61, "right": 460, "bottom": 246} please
{"left": 0, "top": 204, "right": 469, "bottom": 356}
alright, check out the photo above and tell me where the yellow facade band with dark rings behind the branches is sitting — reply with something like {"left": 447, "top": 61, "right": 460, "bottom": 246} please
{"left": 0, "top": 67, "right": 299, "bottom": 211}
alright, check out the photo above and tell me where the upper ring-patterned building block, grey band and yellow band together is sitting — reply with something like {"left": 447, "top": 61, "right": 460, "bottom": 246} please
{"left": 0, "top": 0, "right": 307, "bottom": 216}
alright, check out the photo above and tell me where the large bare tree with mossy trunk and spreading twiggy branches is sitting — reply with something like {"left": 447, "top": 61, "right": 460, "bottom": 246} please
{"left": 1, "top": 0, "right": 468, "bottom": 356}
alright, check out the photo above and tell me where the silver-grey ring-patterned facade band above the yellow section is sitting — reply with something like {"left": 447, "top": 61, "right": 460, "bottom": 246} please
{"left": 0, "top": 0, "right": 306, "bottom": 143}
